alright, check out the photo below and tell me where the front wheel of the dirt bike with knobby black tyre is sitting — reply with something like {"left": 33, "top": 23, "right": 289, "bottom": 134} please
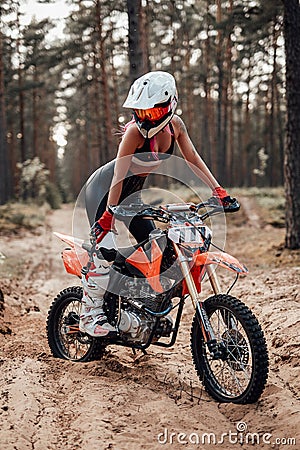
{"left": 191, "top": 294, "right": 269, "bottom": 404}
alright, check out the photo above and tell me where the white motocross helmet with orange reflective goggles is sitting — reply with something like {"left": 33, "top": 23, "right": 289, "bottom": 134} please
{"left": 123, "top": 71, "right": 178, "bottom": 138}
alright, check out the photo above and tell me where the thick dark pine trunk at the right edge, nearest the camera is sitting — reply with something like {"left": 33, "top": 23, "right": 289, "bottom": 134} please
{"left": 283, "top": 0, "right": 300, "bottom": 249}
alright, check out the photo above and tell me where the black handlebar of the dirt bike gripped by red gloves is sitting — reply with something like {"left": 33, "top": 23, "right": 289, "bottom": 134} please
{"left": 110, "top": 197, "right": 240, "bottom": 223}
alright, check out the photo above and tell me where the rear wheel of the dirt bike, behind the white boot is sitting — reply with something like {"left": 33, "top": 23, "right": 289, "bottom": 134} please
{"left": 47, "top": 286, "right": 105, "bottom": 362}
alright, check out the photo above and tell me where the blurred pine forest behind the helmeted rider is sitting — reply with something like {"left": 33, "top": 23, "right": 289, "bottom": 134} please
{"left": 0, "top": 0, "right": 300, "bottom": 244}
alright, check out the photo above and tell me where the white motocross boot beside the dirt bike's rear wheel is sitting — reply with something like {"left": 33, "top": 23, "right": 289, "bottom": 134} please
{"left": 79, "top": 293, "right": 117, "bottom": 337}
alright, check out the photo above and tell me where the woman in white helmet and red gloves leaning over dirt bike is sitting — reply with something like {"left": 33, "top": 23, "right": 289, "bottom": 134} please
{"left": 79, "top": 71, "right": 233, "bottom": 336}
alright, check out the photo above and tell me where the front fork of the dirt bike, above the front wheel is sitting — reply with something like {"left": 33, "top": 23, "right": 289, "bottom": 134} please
{"left": 173, "top": 242, "right": 222, "bottom": 359}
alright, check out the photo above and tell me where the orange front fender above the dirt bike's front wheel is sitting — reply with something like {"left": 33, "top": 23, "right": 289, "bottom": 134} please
{"left": 195, "top": 252, "right": 249, "bottom": 275}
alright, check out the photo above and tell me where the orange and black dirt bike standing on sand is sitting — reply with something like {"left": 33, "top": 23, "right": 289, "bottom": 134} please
{"left": 47, "top": 198, "right": 269, "bottom": 404}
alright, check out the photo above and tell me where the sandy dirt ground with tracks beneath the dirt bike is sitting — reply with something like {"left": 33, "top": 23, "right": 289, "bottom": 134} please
{"left": 0, "top": 203, "right": 300, "bottom": 450}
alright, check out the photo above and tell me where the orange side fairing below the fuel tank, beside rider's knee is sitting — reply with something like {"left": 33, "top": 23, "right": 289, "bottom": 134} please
{"left": 126, "top": 240, "right": 164, "bottom": 293}
